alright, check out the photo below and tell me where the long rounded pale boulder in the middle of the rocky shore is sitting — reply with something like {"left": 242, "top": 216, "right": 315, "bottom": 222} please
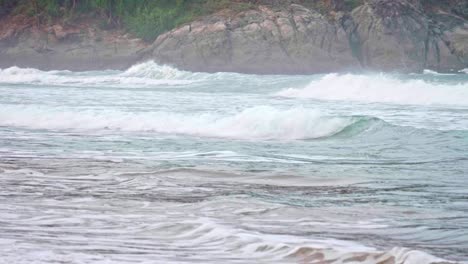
{"left": 152, "top": 4, "right": 358, "bottom": 73}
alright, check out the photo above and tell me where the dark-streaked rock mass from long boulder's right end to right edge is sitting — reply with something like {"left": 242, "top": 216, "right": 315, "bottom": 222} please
{"left": 351, "top": 0, "right": 468, "bottom": 72}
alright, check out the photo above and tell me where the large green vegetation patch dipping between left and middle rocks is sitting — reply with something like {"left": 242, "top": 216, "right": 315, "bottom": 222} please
{"left": 0, "top": 0, "right": 251, "bottom": 41}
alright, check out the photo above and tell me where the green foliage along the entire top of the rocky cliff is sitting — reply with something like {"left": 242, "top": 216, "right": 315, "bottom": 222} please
{"left": 0, "top": 0, "right": 468, "bottom": 42}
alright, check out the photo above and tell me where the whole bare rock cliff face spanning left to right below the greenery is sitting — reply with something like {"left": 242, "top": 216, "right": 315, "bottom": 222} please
{"left": 0, "top": 0, "right": 468, "bottom": 74}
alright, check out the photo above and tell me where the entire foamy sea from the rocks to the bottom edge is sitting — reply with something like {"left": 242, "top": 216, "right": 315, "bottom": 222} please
{"left": 0, "top": 61, "right": 468, "bottom": 264}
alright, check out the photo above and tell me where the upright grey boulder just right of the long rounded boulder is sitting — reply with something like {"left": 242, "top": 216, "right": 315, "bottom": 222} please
{"left": 351, "top": 0, "right": 429, "bottom": 71}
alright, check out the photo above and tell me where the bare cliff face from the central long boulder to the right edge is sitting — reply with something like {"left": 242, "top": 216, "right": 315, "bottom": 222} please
{"left": 150, "top": 0, "right": 468, "bottom": 73}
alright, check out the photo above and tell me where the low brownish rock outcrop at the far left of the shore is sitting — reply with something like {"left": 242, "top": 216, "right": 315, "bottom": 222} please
{"left": 0, "top": 16, "right": 148, "bottom": 71}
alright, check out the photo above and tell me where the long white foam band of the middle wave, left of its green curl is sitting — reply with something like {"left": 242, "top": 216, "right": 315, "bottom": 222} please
{"left": 0, "top": 106, "right": 354, "bottom": 140}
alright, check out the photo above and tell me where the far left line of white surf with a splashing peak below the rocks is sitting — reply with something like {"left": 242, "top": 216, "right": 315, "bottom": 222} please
{"left": 0, "top": 61, "right": 292, "bottom": 88}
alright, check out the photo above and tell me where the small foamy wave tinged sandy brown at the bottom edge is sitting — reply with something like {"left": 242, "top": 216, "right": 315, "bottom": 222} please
{"left": 103, "top": 219, "right": 453, "bottom": 264}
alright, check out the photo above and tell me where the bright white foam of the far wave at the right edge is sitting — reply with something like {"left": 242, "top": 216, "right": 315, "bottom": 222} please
{"left": 276, "top": 74, "right": 468, "bottom": 105}
